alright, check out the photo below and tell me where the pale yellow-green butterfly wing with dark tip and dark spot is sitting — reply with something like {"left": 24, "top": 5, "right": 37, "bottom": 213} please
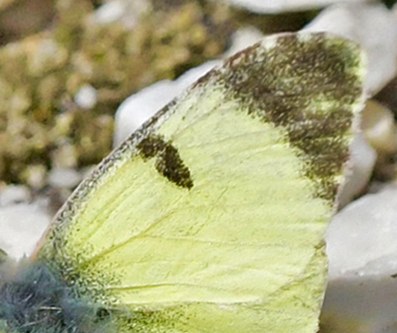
{"left": 39, "top": 34, "right": 363, "bottom": 333}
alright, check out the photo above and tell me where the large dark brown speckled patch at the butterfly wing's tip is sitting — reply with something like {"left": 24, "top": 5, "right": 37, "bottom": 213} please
{"left": 217, "top": 34, "right": 362, "bottom": 202}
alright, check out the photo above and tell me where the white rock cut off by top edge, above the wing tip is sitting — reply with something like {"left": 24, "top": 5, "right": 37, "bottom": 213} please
{"left": 224, "top": 0, "right": 367, "bottom": 14}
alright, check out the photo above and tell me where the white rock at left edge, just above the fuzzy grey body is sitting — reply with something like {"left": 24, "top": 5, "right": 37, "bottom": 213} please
{"left": 0, "top": 201, "right": 51, "bottom": 260}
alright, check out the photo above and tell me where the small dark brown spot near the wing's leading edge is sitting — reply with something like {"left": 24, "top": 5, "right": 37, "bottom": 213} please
{"left": 137, "top": 135, "right": 193, "bottom": 189}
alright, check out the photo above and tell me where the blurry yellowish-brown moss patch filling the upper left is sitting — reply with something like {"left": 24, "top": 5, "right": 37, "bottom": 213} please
{"left": 0, "top": 0, "right": 232, "bottom": 187}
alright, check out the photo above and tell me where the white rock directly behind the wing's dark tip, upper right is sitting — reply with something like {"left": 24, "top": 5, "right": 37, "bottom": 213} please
{"left": 303, "top": 4, "right": 397, "bottom": 96}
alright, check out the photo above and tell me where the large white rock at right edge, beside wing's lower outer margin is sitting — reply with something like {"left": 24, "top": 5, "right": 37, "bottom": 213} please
{"left": 326, "top": 186, "right": 397, "bottom": 279}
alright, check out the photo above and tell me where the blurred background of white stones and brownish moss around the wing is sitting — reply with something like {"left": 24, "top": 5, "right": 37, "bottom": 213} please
{"left": 0, "top": 0, "right": 397, "bottom": 333}
